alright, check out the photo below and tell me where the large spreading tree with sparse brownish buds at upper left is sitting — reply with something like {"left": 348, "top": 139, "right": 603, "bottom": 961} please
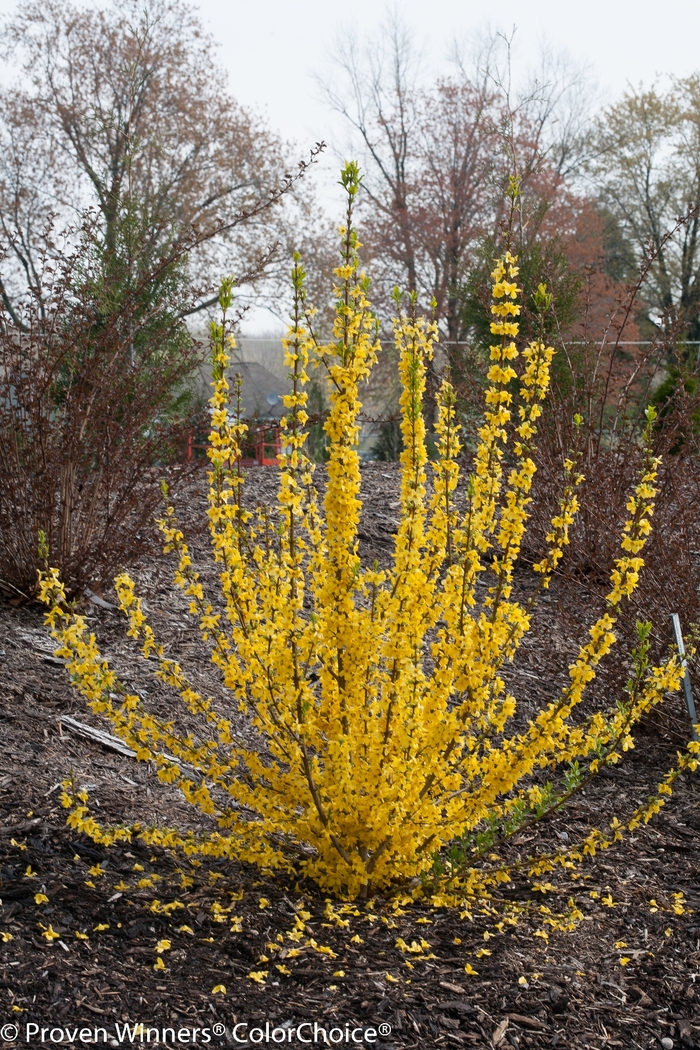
{"left": 0, "top": 0, "right": 312, "bottom": 309}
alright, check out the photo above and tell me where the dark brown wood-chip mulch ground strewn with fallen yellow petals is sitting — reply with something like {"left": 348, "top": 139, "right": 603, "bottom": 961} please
{"left": 0, "top": 464, "right": 700, "bottom": 1050}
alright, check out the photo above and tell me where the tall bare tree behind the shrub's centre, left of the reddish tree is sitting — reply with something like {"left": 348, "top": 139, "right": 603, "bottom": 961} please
{"left": 324, "top": 17, "right": 503, "bottom": 338}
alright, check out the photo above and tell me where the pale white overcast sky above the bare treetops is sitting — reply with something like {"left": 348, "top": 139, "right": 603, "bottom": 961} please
{"left": 199, "top": 0, "right": 700, "bottom": 153}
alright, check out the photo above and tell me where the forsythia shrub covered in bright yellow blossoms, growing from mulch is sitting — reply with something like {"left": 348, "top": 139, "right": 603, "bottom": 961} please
{"left": 41, "top": 164, "right": 695, "bottom": 895}
